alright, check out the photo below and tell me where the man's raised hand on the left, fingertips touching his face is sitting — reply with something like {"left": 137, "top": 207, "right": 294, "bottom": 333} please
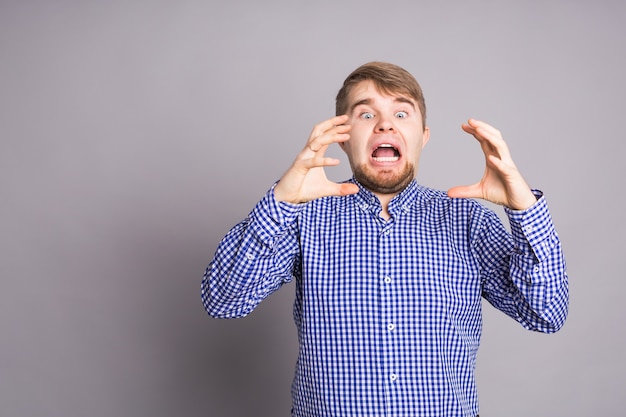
{"left": 274, "top": 115, "right": 359, "bottom": 204}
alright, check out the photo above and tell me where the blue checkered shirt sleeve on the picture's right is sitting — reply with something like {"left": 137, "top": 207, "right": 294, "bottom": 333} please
{"left": 476, "top": 191, "right": 569, "bottom": 333}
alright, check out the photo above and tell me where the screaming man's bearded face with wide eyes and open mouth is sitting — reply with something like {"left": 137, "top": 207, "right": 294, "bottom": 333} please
{"left": 341, "top": 80, "right": 430, "bottom": 194}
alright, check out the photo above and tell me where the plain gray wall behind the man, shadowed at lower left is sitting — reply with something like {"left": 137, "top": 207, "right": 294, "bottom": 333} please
{"left": 0, "top": 0, "right": 626, "bottom": 417}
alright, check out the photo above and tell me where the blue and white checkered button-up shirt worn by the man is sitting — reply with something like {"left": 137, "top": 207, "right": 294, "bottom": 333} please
{"left": 202, "top": 180, "right": 568, "bottom": 417}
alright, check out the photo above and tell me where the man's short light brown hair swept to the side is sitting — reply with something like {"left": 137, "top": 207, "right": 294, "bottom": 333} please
{"left": 335, "top": 61, "right": 426, "bottom": 128}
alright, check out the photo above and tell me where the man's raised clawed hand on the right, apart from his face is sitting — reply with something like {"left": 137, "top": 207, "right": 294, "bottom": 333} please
{"left": 448, "top": 119, "right": 537, "bottom": 210}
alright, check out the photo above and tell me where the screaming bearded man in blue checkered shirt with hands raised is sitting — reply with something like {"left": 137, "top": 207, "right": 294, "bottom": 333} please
{"left": 202, "top": 62, "right": 568, "bottom": 417}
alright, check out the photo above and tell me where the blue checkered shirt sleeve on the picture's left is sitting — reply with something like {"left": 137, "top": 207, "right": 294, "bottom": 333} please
{"left": 201, "top": 185, "right": 303, "bottom": 318}
